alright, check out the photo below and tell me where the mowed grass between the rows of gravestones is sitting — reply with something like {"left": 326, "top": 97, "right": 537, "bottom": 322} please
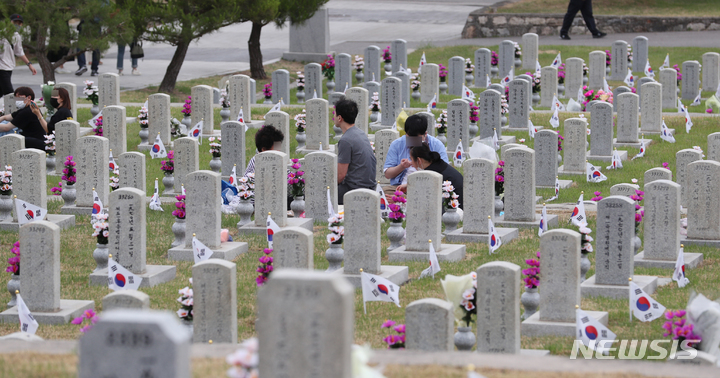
{"left": 0, "top": 43, "right": 720, "bottom": 366}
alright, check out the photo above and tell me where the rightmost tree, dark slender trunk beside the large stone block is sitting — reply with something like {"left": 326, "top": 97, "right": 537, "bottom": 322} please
{"left": 248, "top": 0, "right": 328, "bottom": 79}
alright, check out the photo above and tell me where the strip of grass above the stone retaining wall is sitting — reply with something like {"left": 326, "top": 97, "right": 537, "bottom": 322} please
{"left": 497, "top": 0, "right": 720, "bottom": 17}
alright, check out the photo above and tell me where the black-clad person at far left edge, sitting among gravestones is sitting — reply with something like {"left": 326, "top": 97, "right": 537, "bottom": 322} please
{"left": 0, "top": 87, "right": 47, "bottom": 151}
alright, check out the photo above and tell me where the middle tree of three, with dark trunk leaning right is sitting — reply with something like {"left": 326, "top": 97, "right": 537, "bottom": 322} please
{"left": 135, "top": 0, "right": 262, "bottom": 93}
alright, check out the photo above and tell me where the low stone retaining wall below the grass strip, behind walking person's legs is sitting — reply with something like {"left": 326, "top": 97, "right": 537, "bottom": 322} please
{"left": 462, "top": 9, "right": 720, "bottom": 38}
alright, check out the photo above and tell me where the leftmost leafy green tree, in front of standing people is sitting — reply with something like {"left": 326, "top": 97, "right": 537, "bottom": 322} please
{"left": 0, "top": 0, "right": 129, "bottom": 82}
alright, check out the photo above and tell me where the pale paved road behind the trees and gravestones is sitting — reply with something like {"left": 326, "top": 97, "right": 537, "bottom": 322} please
{"left": 7, "top": 0, "right": 717, "bottom": 95}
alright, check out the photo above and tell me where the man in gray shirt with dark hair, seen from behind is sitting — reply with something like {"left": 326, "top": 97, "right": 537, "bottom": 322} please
{"left": 333, "top": 99, "right": 376, "bottom": 205}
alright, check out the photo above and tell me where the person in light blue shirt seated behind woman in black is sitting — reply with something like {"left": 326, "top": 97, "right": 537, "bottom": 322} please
{"left": 383, "top": 114, "right": 449, "bottom": 194}
